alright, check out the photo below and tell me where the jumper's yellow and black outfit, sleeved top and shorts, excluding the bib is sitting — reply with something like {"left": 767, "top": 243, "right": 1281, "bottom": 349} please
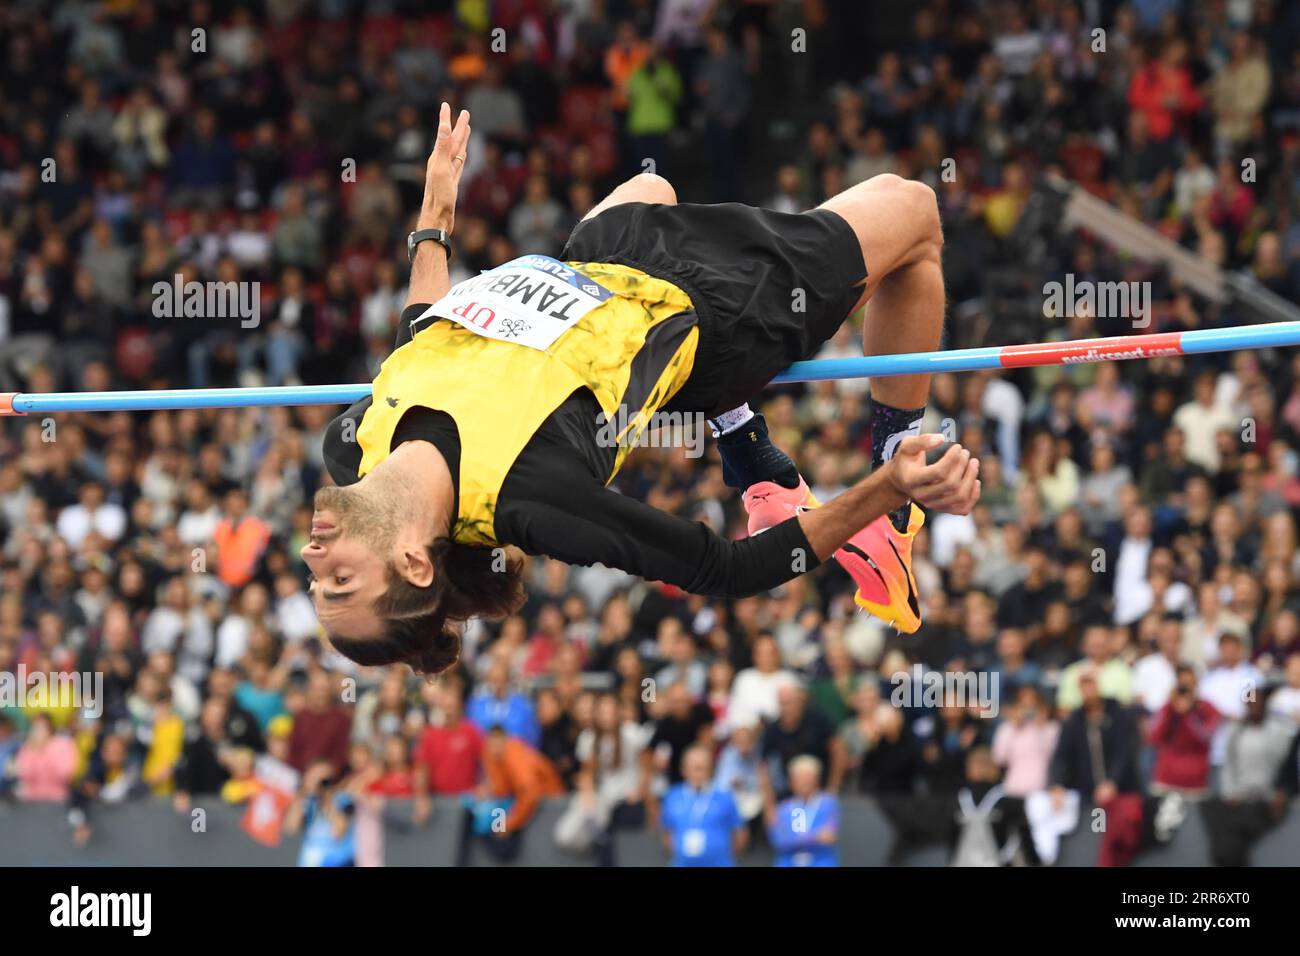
{"left": 325, "top": 204, "right": 865, "bottom": 596}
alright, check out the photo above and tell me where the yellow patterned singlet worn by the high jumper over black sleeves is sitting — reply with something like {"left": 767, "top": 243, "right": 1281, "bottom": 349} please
{"left": 356, "top": 263, "right": 699, "bottom": 546}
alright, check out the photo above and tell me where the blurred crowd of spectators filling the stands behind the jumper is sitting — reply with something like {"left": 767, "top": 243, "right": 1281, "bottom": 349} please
{"left": 0, "top": 0, "right": 1300, "bottom": 864}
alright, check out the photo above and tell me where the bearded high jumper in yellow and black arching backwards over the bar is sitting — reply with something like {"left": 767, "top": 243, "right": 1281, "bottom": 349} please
{"left": 302, "top": 104, "right": 980, "bottom": 672}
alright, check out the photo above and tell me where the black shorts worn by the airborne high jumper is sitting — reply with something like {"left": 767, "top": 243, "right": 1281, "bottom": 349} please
{"left": 560, "top": 203, "right": 867, "bottom": 415}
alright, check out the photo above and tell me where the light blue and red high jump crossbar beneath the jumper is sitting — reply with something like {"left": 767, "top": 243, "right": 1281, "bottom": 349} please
{"left": 0, "top": 321, "right": 1300, "bottom": 416}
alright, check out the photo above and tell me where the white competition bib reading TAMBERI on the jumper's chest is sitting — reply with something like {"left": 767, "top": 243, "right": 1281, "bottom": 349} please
{"left": 412, "top": 255, "right": 614, "bottom": 351}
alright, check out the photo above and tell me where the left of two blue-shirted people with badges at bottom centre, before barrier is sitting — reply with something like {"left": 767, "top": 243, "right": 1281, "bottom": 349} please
{"left": 659, "top": 745, "right": 749, "bottom": 866}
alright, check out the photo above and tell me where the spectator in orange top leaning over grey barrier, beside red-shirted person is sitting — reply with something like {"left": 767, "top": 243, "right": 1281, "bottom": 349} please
{"left": 456, "top": 724, "right": 564, "bottom": 866}
